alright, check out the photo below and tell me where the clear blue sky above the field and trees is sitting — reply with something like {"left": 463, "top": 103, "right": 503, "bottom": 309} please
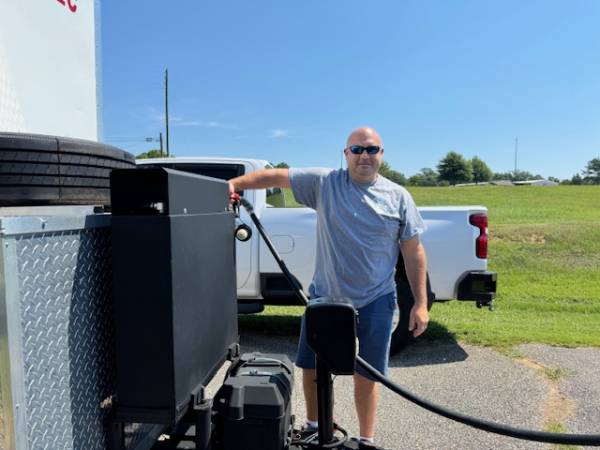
{"left": 101, "top": 0, "right": 600, "bottom": 178}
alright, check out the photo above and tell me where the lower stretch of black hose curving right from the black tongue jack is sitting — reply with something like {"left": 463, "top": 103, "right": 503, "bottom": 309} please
{"left": 356, "top": 355, "right": 600, "bottom": 447}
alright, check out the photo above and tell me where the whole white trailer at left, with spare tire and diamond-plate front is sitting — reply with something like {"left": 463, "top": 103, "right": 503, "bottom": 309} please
{"left": 0, "top": 0, "right": 166, "bottom": 450}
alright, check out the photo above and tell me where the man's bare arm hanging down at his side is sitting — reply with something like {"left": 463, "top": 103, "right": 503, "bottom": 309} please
{"left": 400, "top": 235, "right": 429, "bottom": 337}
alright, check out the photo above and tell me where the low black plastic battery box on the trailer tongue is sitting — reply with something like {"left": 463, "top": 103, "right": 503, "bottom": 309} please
{"left": 213, "top": 353, "right": 294, "bottom": 450}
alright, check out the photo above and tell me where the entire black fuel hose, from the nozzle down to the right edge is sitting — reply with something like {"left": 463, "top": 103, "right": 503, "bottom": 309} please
{"left": 234, "top": 198, "right": 600, "bottom": 447}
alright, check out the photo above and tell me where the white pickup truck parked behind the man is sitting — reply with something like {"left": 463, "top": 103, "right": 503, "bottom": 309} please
{"left": 137, "top": 157, "right": 496, "bottom": 352}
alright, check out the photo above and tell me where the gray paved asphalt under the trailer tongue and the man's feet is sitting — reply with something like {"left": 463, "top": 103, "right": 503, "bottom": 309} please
{"left": 229, "top": 332, "right": 600, "bottom": 450}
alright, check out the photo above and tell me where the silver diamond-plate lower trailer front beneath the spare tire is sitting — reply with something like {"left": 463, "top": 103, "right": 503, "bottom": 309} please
{"left": 0, "top": 206, "right": 161, "bottom": 450}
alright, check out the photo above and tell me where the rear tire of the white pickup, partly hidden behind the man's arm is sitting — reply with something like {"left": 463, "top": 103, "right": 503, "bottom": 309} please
{"left": 390, "top": 255, "right": 435, "bottom": 356}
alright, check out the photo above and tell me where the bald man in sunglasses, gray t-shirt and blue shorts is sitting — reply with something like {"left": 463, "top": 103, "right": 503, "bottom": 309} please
{"left": 229, "top": 127, "right": 429, "bottom": 443}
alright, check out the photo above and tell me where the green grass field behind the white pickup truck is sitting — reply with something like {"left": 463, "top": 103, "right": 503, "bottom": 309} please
{"left": 242, "top": 186, "right": 600, "bottom": 349}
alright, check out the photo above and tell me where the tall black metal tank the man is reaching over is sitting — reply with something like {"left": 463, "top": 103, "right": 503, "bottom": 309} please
{"left": 111, "top": 168, "right": 238, "bottom": 424}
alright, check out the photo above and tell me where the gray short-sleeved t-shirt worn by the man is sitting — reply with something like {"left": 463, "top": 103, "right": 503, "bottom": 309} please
{"left": 289, "top": 168, "right": 425, "bottom": 308}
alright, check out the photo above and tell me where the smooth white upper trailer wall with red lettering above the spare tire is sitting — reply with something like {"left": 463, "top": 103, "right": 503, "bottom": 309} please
{"left": 0, "top": 0, "right": 101, "bottom": 141}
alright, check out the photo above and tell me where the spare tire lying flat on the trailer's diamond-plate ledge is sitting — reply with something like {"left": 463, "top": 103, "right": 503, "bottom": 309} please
{"left": 0, "top": 133, "right": 135, "bottom": 206}
